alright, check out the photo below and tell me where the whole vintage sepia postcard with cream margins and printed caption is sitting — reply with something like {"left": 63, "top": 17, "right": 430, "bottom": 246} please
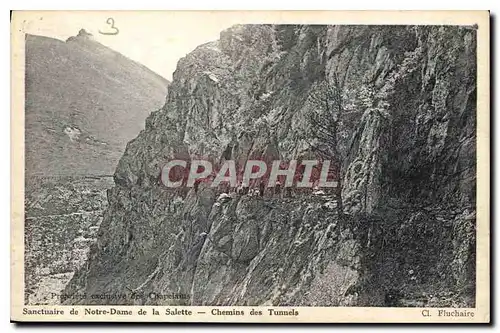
{"left": 11, "top": 11, "right": 490, "bottom": 322}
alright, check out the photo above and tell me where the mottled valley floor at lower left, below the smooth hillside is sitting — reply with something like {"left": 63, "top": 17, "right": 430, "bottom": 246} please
{"left": 24, "top": 178, "right": 113, "bottom": 305}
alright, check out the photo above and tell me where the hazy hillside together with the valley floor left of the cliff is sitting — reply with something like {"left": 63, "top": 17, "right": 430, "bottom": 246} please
{"left": 25, "top": 30, "right": 169, "bottom": 304}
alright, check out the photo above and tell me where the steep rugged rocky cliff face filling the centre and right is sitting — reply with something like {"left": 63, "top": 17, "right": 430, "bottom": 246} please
{"left": 65, "top": 25, "right": 476, "bottom": 306}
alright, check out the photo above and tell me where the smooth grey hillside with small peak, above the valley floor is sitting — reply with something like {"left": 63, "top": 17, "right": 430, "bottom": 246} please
{"left": 25, "top": 35, "right": 168, "bottom": 177}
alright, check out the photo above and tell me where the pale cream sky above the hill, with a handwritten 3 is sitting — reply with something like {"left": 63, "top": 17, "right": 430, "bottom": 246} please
{"left": 19, "top": 11, "right": 236, "bottom": 80}
